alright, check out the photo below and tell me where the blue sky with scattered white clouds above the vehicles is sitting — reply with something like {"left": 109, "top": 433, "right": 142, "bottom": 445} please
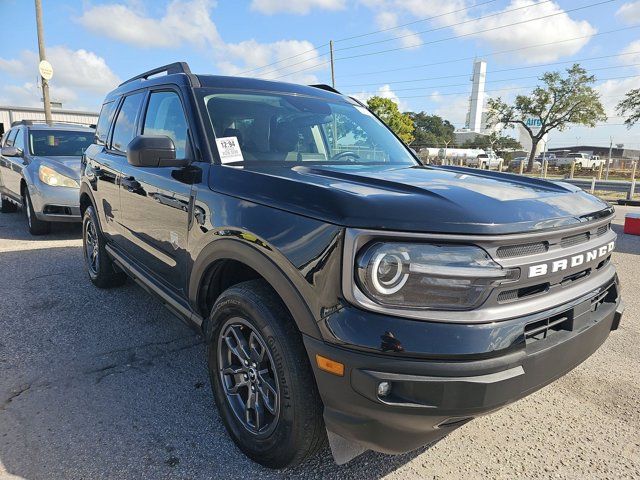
{"left": 0, "top": 0, "right": 640, "bottom": 149}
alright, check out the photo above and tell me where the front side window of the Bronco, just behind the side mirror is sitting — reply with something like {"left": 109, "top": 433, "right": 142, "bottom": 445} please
{"left": 142, "top": 92, "right": 187, "bottom": 158}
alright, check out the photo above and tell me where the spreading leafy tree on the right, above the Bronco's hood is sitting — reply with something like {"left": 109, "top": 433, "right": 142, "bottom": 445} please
{"left": 488, "top": 64, "right": 607, "bottom": 172}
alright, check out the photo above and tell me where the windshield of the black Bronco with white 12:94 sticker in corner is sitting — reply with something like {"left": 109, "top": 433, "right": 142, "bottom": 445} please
{"left": 200, "top": 89, "right": 417, "bottom": 166}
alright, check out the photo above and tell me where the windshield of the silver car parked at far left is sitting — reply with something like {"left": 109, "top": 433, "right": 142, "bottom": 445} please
{"left": 29, "top": 130, "right": 94, "bottom": 157}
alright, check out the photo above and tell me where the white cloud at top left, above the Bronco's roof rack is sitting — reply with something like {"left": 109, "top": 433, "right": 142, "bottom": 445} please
{"left": 78, "top": 0, "right": 221, "bottom": 48}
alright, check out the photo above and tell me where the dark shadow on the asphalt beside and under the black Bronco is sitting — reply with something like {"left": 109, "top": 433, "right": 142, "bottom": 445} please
{"left": 0, "top": 244, "right": 424, "bottom": 480}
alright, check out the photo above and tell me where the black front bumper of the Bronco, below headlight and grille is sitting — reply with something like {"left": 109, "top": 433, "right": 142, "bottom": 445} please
{"left": 304, "top": 278, "right": 624, "bottom": 454}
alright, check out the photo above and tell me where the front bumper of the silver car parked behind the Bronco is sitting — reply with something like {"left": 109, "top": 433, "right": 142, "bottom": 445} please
{"left": 29, "top": 180, "right": 82, "bottom": 222}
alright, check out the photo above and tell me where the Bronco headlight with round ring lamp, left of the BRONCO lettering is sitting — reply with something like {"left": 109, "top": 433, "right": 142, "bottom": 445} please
{"left": 355, "top": 242, "right": 520, "bottom": 310}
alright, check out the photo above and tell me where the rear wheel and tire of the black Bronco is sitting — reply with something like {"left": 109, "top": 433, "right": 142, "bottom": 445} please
{"left": 82, "top": 206, "right": 127, "bottom": 288}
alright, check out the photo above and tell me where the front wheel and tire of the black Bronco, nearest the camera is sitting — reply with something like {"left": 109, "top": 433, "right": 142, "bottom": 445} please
{"left": 207, "top": 280, "right": 326, "bottom": 468}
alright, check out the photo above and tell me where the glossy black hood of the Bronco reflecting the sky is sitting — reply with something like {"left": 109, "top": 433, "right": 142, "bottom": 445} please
{"left": 210, "top": 164, "right": 613, "bottom": 234}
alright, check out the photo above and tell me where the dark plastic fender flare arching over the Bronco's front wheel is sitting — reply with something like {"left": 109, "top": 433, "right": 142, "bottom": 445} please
{"left": 189, "top": 239, "right": 321, "bottom": 338}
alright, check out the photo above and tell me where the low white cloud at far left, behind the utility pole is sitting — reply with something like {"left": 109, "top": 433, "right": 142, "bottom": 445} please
{"left": 0, "top": 45, "right": 120, "bottom": 108}
